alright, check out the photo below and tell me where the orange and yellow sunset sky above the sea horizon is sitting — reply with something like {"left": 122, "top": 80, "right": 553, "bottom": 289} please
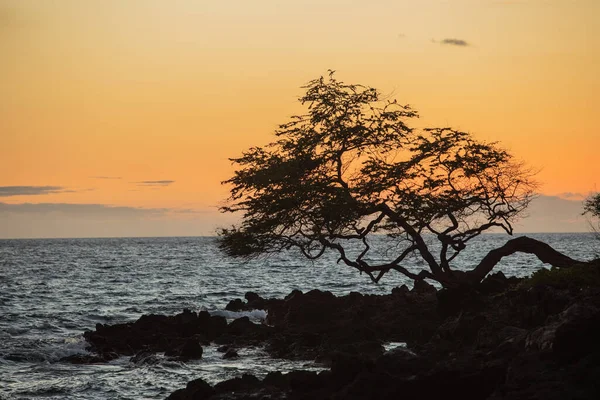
{"left": 0, "top": 0, "right": 600, "bottom": 238}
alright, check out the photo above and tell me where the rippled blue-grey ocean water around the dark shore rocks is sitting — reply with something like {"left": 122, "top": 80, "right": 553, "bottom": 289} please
{"left": 0, "top": 233, "right": 600, "bottom": 399}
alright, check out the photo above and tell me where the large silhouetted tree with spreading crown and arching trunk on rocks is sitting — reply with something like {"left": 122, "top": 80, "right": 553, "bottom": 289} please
{"left": 219, "top": 71, "right": 574, "bottom": 286}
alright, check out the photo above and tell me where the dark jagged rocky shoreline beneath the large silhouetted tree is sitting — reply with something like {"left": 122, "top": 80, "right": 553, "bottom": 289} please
{"left": 64, "top": 262, "right": 600, "bottom": 400}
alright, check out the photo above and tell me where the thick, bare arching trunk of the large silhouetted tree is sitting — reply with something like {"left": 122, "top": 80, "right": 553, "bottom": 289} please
{"left": 467, "top": 236, "right": 581, "bottom": 282}
